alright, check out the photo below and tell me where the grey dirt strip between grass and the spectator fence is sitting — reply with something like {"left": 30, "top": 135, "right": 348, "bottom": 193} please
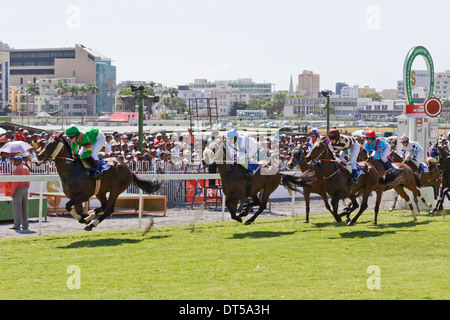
{"left": 0, "top": 197, "right": 383, "bottom": 238}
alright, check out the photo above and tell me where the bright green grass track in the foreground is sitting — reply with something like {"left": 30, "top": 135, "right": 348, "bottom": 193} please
{"left": 0, "top": 211, "right": 450, "bottom": 300}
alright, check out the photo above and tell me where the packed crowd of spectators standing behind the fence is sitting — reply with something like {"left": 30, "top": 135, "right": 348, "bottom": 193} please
{"left": 0, "top": 128, "right": 447, "bottom": 173}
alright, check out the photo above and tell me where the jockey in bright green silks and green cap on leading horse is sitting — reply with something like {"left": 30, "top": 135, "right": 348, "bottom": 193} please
{"left": 66, "top": 126, "right": 106, "bottom": 180}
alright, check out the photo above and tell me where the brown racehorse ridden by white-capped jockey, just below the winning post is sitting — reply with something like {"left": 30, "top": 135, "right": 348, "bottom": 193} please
{"left": 389, "top": 151, "right": 441, "bottom": 214}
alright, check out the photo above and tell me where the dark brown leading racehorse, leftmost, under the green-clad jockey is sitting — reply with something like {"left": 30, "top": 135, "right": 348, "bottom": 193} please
{"left": 37, "top": 133, "right": 161, "bottom": 231}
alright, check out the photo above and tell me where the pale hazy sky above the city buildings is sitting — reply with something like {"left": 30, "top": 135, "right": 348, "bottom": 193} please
{"left": 0, "top": 0, "right": 450, "bottom": 91}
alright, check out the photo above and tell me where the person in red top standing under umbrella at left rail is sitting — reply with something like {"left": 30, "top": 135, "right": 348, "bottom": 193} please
{"left": 11, "top": 156, "right": 30, "bottom": 230}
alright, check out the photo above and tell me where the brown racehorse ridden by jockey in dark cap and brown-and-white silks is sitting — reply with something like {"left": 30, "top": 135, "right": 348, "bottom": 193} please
{"left": 306, "top": 137, "right": 379, "bottom": 226}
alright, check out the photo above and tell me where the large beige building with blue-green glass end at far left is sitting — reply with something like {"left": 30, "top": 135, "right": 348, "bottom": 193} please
{"left": 0, "top": 44, "right": 116, "bottom": 115}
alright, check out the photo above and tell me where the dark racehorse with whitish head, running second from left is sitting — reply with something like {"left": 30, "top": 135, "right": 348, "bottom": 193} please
{"left": 202, "top": 139, "right": 312, "bottom": 225}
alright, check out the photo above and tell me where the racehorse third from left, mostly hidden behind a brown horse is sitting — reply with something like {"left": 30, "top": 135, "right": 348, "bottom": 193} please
{"left": 288, "top": 147, "right": 336, "bottom": 223}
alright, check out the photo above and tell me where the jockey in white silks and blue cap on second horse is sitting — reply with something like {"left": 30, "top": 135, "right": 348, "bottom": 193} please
{"left": 225, "top": 129, "right": 258, "bottom": 177}
